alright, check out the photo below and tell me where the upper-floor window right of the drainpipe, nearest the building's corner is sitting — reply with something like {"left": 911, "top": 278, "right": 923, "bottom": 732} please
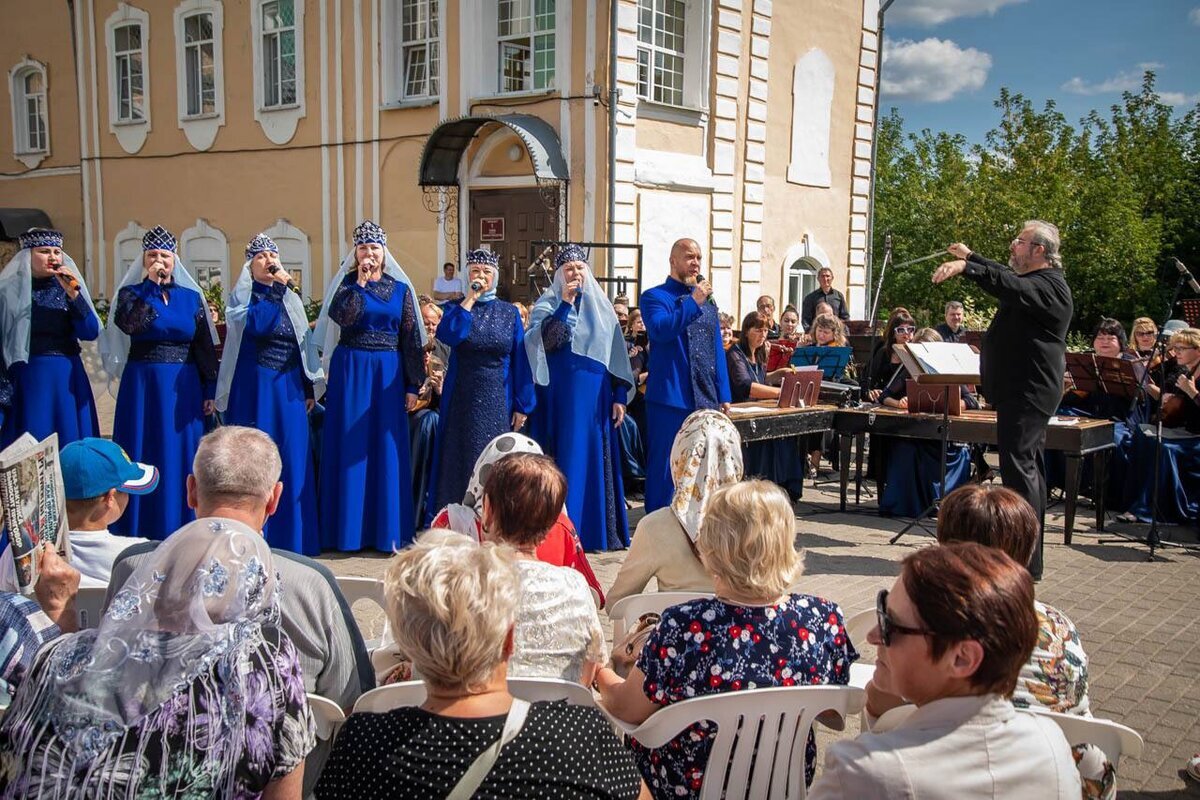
{"left": 637, "top": 0, "right": 686, "bottom": 106}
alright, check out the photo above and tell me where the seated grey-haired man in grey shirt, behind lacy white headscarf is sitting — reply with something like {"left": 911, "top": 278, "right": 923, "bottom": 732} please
{"left": 108, "top": 425, "right": 374, "bottom": 795}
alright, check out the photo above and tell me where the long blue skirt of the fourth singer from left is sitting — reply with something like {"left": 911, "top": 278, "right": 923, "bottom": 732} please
{"left": 320, "top": 347, "right": 414, "bottom": 553}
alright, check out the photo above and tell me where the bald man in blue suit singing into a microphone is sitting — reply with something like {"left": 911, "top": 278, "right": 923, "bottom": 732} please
{"left": 640, "top": 239, "right": 730, "bottom": 513}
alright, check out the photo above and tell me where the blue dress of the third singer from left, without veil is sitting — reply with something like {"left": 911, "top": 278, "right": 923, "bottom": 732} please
{"left": 224, "top": 281, "right": 320, "bottom": 555}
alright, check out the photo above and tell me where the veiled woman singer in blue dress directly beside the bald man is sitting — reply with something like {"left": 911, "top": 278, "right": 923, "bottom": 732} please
{"left": 524, "top": 245, "right": 634, "bottom": 551}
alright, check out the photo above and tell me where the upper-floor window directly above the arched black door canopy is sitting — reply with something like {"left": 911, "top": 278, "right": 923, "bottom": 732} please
{"left": 497, "top": 0, "right": 554, "bottom": 92}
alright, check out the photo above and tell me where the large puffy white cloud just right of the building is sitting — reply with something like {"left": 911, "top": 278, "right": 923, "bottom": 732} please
{"left": 882, "top": 38, "right": 995, "bottom": 103}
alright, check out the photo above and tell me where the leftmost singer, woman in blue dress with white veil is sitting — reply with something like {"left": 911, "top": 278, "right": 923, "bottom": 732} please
{"left": 0, "top": 228, "right": 100, "bottom": 450}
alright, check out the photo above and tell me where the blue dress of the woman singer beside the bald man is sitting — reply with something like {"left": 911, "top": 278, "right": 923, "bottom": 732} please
{"left": 538, "top": 297, "right": 632, "bottom": 551}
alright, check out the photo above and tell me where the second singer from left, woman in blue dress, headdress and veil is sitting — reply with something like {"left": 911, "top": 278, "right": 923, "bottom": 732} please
{"left": 101, "top": 225, "right": 217, "bottom": 539}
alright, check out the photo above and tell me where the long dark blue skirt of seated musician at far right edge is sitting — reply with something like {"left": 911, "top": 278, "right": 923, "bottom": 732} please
{"left": 1126, "top": 426, "right": 1200, "bottom": 523}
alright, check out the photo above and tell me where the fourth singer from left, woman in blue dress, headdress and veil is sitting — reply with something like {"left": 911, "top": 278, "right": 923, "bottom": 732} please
{"left": 316, "top": 219, "right": 425, "bottom": 553}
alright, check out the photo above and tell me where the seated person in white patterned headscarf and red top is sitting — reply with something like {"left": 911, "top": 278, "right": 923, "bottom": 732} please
{"left": 431, "top": 433, "right": 605, "bottom": 597}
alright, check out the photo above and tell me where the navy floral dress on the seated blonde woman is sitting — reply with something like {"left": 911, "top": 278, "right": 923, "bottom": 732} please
{"left": 634, "top": 595, "right": 858, "bottom": 799}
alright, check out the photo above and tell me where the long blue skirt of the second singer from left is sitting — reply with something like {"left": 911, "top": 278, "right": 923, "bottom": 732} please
{"left": 110, "top": 361, "right": 204, "bottom": 540}
